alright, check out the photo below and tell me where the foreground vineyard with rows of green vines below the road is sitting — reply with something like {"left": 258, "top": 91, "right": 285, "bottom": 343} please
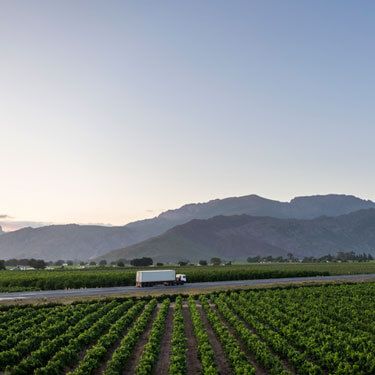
{"left": 0, "top": 283, "right": 375, "bottom": 375}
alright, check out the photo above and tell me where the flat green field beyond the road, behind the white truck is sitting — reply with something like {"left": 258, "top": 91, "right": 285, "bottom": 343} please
{"left": 0, "top": 262, "right": 375, "bottom": 292}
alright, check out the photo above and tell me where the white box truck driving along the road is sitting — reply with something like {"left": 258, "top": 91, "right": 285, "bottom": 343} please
{"left": 135, "top": 270, "right": 186, "bottom": 288}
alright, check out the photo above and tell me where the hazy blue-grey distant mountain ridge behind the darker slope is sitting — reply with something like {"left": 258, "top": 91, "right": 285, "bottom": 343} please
{"left": 0, "top": 194, "right": 375, "bottom": 260}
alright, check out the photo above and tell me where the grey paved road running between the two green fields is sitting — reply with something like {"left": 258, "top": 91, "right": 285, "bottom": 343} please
{"left": 0, "top": 274, "right": 375, "bottom": 301}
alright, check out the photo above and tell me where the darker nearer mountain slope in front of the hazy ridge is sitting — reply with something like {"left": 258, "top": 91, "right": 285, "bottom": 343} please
{"left": 100, "top": 209, "right": 375, "bottom": 262}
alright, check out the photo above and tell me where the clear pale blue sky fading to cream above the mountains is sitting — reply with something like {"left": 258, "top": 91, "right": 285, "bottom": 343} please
{"left": 0, "top": 0, "right": 375, "bottom": 230}
